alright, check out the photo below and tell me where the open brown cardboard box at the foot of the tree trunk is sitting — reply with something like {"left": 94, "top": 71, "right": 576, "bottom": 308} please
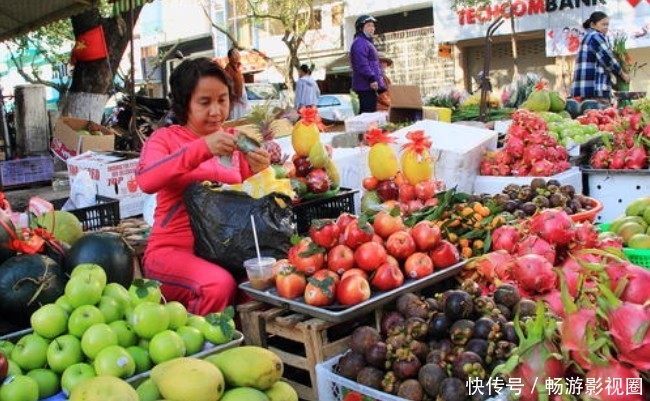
{"left": 50, "top": 117, "right": 115, "bottom": 161}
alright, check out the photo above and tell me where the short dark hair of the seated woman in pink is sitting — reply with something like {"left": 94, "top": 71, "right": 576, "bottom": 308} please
{"left": 169, "top": 57, "right": 233, "bottom": 125}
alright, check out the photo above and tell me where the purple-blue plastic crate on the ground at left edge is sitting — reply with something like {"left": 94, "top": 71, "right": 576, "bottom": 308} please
{"left": 0, "top": 156, "right": 54, "bottom": 189}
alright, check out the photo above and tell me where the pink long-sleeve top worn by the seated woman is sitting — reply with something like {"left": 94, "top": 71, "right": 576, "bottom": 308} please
{"left": 136, "top": 125, "right": 251, "bottom": 252}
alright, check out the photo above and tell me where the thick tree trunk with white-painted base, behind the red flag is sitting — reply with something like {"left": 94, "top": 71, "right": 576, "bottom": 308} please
{"left": 61, "top": 7, "right": 142, "bottom": 122}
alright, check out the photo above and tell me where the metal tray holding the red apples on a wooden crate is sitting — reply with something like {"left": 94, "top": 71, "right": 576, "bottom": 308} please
{"left": 239, "top": 261, "right": 467, "bottom": 323}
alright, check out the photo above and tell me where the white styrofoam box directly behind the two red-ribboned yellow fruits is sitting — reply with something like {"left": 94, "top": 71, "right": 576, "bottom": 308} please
{"left": 393, "top": 120, "right": 497, "bottom": 193}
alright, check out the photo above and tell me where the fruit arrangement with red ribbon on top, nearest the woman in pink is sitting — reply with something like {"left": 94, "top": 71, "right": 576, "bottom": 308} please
{"left": 287, "top": 107, "right": 341, "bottom": 197}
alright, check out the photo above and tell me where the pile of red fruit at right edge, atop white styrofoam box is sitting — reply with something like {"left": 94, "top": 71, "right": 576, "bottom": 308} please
{"left": 590, "top": 103, "right": 650, "bottom": 170}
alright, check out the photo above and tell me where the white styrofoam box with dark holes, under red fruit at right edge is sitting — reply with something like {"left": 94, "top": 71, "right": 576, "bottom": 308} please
{"left": 582, "top": 168, "right": 650, "bottom": 223}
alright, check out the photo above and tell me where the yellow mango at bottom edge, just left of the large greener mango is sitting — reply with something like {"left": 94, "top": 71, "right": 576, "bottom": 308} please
{"left": 151, "top": 358, "right": 225, "bottom": 401}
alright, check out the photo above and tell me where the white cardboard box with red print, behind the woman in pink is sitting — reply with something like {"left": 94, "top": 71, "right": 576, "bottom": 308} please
{"left": 67, "top": 152, "right": 146, "bottom": 218}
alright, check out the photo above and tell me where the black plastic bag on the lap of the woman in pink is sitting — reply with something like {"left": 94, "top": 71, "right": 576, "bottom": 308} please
{"left": 184, "top": 183, "right": 294, "bottom": 278}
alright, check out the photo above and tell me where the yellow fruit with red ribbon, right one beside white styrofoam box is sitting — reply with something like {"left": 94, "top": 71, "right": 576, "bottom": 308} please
{"left": 402, "top": 130, "right": 434, "bottom": 185}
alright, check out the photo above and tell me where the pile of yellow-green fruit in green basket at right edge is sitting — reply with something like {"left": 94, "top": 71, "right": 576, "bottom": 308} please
{"left": 608, "top": 196, "right": 650, "bottom": 249}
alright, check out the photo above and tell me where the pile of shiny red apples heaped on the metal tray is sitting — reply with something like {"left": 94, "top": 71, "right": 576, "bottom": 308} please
{"left": 274, "top": 211, "right": 459, "bottom": 307}
